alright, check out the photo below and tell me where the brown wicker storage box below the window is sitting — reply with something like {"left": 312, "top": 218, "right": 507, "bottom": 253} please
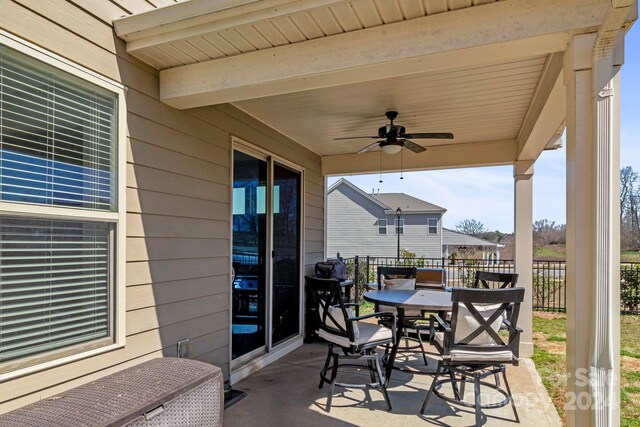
{"left": 0, "top": 358, "right": 224, "bottom": 427}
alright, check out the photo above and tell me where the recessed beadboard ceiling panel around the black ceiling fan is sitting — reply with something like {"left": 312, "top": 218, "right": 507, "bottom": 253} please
{"left": 234, "top": 56, "right": 547, "bottom": 156}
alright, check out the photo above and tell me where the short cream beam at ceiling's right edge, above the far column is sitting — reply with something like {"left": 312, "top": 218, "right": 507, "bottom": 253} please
{"left": 517, "top": 52, "right": 566, "bottom": 160}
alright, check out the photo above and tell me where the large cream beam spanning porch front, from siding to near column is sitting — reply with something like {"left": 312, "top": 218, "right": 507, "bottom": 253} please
{"left": 160, "top": 0, "right": 608, "bottom": 108}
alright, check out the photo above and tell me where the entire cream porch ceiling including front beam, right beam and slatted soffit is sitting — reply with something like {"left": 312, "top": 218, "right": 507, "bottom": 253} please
{"left": 114, "top": 0, "right": 609, "bottom": 166}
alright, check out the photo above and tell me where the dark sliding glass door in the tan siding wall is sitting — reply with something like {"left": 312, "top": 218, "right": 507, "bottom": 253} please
{"left": 231, "top": 150, "right": 302, "bottom": 360}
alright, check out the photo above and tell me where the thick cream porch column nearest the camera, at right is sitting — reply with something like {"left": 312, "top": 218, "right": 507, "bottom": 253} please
{"left": 564, "top": 27, "right": 624, "bottom": 426}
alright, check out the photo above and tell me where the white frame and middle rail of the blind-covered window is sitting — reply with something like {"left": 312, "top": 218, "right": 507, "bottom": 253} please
{"left": 0, "top": 29, "right": 127, "bottom": 382}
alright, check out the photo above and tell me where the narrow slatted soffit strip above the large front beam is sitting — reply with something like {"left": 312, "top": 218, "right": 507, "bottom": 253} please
{"left": 123, "top": 0, "right": 501, "bottom": 70}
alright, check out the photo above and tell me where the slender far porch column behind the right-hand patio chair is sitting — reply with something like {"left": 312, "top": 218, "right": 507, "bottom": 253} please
{"left": 513, "top": 160, "right": 534, "bottom": 357}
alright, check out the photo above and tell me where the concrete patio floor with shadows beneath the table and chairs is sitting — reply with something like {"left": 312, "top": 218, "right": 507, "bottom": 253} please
{"left": 224, "top": 343, "right": 561, "bottom": 427}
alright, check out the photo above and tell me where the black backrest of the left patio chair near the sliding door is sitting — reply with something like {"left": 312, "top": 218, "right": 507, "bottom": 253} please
{"left": 304, "top": 276, "right": 354, "bottom": 341}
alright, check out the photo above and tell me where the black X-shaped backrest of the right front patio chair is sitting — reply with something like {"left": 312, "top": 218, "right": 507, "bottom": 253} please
{"left": 443, "top": 288, "right": 525, "bottom": 358}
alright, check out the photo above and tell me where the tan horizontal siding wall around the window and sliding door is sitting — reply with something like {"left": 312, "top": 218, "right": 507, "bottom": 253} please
{"left": 0, "top": 0, "right": 324, "bottom": 413}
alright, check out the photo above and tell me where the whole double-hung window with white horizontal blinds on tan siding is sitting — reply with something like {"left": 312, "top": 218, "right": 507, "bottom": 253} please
{"left": 0, "top": 34, "right": 124, "bottom": 374}
